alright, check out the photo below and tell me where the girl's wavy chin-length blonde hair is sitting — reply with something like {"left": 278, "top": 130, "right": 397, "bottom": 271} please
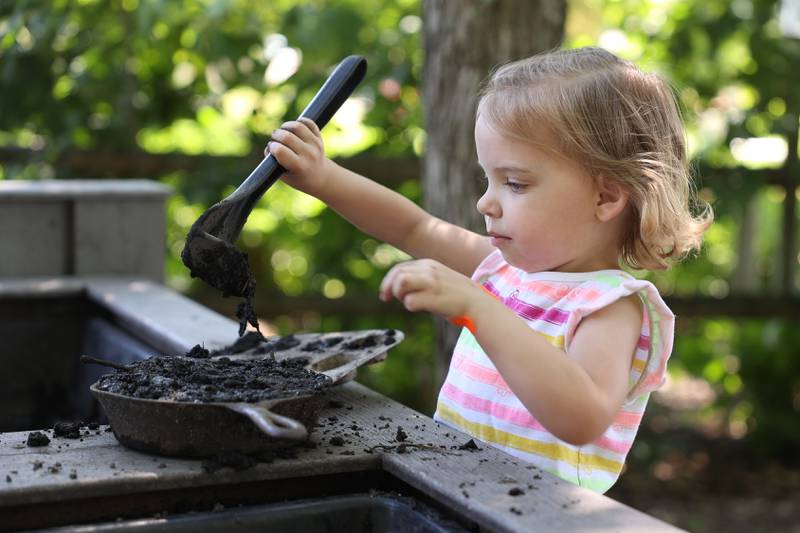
{"left": 478, "top": 48, "right": 714, "bottom": 270}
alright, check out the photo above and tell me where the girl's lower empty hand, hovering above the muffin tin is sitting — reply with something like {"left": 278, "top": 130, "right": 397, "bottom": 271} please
{"left": 379, "top": 259, "right": 483, "bottom": 318}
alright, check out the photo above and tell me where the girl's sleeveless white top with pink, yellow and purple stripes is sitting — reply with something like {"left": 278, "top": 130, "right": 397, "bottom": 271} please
{"left": 434, "top": 251, "right": 675, "bottom": 493}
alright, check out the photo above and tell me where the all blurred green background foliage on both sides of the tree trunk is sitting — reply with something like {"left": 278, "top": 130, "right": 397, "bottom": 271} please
{"left": 0, "top": 0, "right": 800, "bottom": 454}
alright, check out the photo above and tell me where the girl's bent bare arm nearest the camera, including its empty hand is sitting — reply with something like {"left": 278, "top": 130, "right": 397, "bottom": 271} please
{"left": 381, "top": 260, "right": 642, "bottom": 445}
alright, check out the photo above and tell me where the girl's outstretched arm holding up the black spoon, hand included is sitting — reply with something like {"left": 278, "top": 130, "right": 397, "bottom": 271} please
{"left": 267, "top": 118, "right": 494, "bottom": 276}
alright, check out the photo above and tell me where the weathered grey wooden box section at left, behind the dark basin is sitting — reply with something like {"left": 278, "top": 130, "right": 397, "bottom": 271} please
{"left": 0, "top": 180, "right": 171, "bottom": 282}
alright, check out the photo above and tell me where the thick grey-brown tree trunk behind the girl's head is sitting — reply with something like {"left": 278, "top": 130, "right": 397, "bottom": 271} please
{"left": 422, "top": 0, "right": 566, "bottom": 380}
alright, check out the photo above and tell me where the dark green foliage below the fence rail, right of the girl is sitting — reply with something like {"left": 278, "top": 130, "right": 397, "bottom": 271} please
{"left": 670, "top": 319, "right": 800, "bottom": 460}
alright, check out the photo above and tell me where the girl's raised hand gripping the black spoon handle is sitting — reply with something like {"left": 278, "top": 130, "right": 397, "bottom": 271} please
{"left": 264, "top": 117, "right": 330, "bottom": 195}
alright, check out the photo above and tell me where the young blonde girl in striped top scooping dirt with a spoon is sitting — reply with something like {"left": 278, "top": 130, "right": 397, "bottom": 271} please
{"left": 267, "top": 48, "right": 712, "bottom": 492}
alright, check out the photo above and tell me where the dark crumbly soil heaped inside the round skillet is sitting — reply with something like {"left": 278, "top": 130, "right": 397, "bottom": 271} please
{"left": 97, "top": 356, "right": 331, "bottom": 402}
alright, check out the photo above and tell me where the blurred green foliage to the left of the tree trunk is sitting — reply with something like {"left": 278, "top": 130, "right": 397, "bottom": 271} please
{"left": 0, "top": 0, "right": 435, "bottom": 409}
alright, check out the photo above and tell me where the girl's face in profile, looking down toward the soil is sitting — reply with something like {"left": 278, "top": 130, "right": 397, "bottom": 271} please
{"left": 475, "top": 116, "right": 618, "bottom": 272}
